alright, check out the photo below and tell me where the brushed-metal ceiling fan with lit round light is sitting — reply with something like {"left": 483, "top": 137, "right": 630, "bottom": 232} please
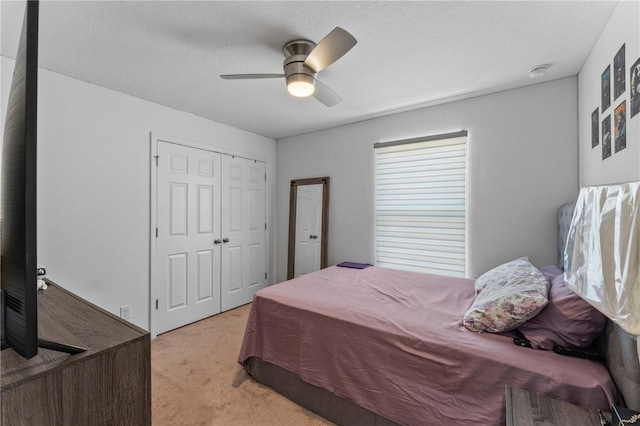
{"left": 220, "top": 27, "right": 357, "bottom": 107}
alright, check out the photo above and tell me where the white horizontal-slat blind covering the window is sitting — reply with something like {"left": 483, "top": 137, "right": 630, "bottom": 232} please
{"left": 375, "top": 131, "right": 467, "bottom": 277}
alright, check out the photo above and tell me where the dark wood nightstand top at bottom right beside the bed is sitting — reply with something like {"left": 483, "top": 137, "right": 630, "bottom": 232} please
{"left": 506, "top": 386, "right": 601, "bottom": 426}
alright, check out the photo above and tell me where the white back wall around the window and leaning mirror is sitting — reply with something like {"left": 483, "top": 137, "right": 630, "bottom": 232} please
{"left": 277, "top": 77, "right": 578, "bottom": 280}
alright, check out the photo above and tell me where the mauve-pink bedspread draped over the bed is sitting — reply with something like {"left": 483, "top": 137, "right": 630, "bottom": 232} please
{"left": 238, "top": 267, "right": 615, "bottom": 425}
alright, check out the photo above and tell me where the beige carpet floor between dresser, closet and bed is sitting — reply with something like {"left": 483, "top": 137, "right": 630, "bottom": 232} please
{"left": 151, "top": 305, "right": 333, "bottom": 426}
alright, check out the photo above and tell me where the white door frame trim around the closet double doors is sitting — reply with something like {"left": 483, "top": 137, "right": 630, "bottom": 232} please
{"left": 149, "top": 132, "right": 272, "bottom": 339}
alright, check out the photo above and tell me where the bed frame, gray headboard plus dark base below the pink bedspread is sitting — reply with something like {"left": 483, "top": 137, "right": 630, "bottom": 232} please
{"left": 244, "top": 204, "right": 640, "bottom": 426}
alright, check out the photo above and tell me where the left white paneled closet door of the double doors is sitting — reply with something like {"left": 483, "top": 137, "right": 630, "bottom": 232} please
{"left": 155, "top": 141, "right": 222, "bottom": 333}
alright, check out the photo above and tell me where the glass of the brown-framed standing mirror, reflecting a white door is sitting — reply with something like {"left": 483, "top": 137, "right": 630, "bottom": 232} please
{"left": 293, "top": 184, "right": 322, "bottom": 277}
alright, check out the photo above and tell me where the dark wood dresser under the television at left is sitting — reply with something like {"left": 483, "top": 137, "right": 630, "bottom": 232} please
{"left": 0, "top": 281, "right": 151, "bottom": 426}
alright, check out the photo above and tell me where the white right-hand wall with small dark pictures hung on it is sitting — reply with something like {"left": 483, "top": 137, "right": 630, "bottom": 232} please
{"left": 578, "top": 1, "right": 640, "bottom": 186}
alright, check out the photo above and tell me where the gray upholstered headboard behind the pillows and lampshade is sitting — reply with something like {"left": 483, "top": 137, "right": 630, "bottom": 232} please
{"left": 558, "top": 203, "right": 640, "bottom": 411}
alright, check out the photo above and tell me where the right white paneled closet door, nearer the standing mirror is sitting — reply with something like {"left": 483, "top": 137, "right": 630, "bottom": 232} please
{"left": 221, "top": 155, "right": 267, "bottom": 311}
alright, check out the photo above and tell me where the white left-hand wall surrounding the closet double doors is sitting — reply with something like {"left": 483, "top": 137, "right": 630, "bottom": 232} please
{"left": 2, "top": 57, "right": 276, "bottom": 329}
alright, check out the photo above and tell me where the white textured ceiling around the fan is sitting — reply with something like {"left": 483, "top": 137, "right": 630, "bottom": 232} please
{"left": 0, "top": 0, "right": 616, "bottom": 139}
